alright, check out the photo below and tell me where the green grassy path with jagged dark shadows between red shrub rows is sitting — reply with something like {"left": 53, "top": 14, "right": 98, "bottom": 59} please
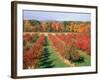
{"left": 37, "top": 37, "right": 69, "bottom": 68}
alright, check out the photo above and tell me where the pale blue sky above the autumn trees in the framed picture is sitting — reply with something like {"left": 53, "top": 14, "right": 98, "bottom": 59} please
{"left": 23, "top": 10, "right": 91, "bottom": 21}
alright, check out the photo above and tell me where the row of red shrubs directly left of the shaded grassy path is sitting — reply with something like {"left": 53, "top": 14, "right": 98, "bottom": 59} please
{"left": 23, "top": 35, "right": 44, "bottom": 69}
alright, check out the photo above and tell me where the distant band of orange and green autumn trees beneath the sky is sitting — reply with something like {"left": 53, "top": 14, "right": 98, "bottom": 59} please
{"left": 23, "top": 20, "right": 91, "bottom": 32}
